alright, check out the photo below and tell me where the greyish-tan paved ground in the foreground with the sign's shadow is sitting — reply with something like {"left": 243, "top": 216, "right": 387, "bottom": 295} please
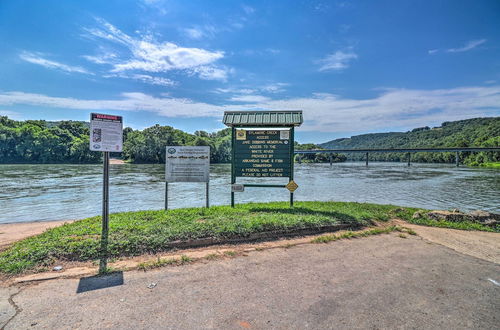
{"left": 0, "top": 232, "right": 500, "bottom": 329}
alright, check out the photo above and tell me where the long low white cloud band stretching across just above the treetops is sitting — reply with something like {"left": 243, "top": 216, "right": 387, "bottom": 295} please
{"left": 0, "top": 85, "right": 500, "bottom": 133}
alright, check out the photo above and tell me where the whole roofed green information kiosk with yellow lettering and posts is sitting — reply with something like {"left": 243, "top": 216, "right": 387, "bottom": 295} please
{"left": 224, "top": 110, "right": 303, "bottom": 207}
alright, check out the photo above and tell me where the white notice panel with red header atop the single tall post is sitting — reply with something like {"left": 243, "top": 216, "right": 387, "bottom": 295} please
{"left": 90, "top": 113, "right": 123, "bottom": 152}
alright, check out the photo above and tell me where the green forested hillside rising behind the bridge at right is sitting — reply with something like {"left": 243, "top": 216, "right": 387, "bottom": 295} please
{"left": 320, "top": 117, "right": 500, "bottom": 165}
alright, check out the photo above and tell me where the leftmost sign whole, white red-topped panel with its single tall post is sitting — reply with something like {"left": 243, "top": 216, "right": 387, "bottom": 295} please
{"left": 90, "top": 113, "right": 123, "bottom": 274}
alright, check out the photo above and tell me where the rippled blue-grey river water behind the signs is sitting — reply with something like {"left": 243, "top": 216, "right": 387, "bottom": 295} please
{"left": 0, "top": 162, "right": 500, "bottom": 223}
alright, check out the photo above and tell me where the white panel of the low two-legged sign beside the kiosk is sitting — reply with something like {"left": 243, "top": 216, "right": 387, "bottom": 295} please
{"left": 165, "top": 146, "right": 210, "bottom": 182}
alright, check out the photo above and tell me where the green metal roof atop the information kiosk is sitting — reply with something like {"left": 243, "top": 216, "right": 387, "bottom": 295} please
{"left": 223, "top": 110, "right": 303, "bottom": 127}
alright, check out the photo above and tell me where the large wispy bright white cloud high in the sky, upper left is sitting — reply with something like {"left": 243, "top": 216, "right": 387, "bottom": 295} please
{"left": 85, "top": 19, "right": 228, "bottom": 80}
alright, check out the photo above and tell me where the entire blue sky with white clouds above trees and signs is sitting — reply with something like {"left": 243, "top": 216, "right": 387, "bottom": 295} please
{"left": 0, "top": 0, "right": 500, "bottom": 143}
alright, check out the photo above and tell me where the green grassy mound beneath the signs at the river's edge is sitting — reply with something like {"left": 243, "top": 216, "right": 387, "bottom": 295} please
{"left": 0, "top": 202, "right": 416, "bottom": 274}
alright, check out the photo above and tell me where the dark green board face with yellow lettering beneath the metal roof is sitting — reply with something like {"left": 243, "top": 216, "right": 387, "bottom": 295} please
{"left": 234, "top": 129, "right": 293, "bottom": 177}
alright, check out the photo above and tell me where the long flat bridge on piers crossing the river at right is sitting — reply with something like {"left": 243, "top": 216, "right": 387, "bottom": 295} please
{"left": 295, "top": 147, "right": 500, "bottom": 166}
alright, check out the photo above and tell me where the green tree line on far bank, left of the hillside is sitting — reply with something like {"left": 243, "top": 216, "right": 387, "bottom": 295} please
{"left": 0, "top": 116, "right": 338, "bottom": 164}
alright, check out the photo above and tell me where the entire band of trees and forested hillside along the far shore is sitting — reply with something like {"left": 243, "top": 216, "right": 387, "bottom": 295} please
{"left": 0, "top": 116, "right": 500, "bottom": 165}
